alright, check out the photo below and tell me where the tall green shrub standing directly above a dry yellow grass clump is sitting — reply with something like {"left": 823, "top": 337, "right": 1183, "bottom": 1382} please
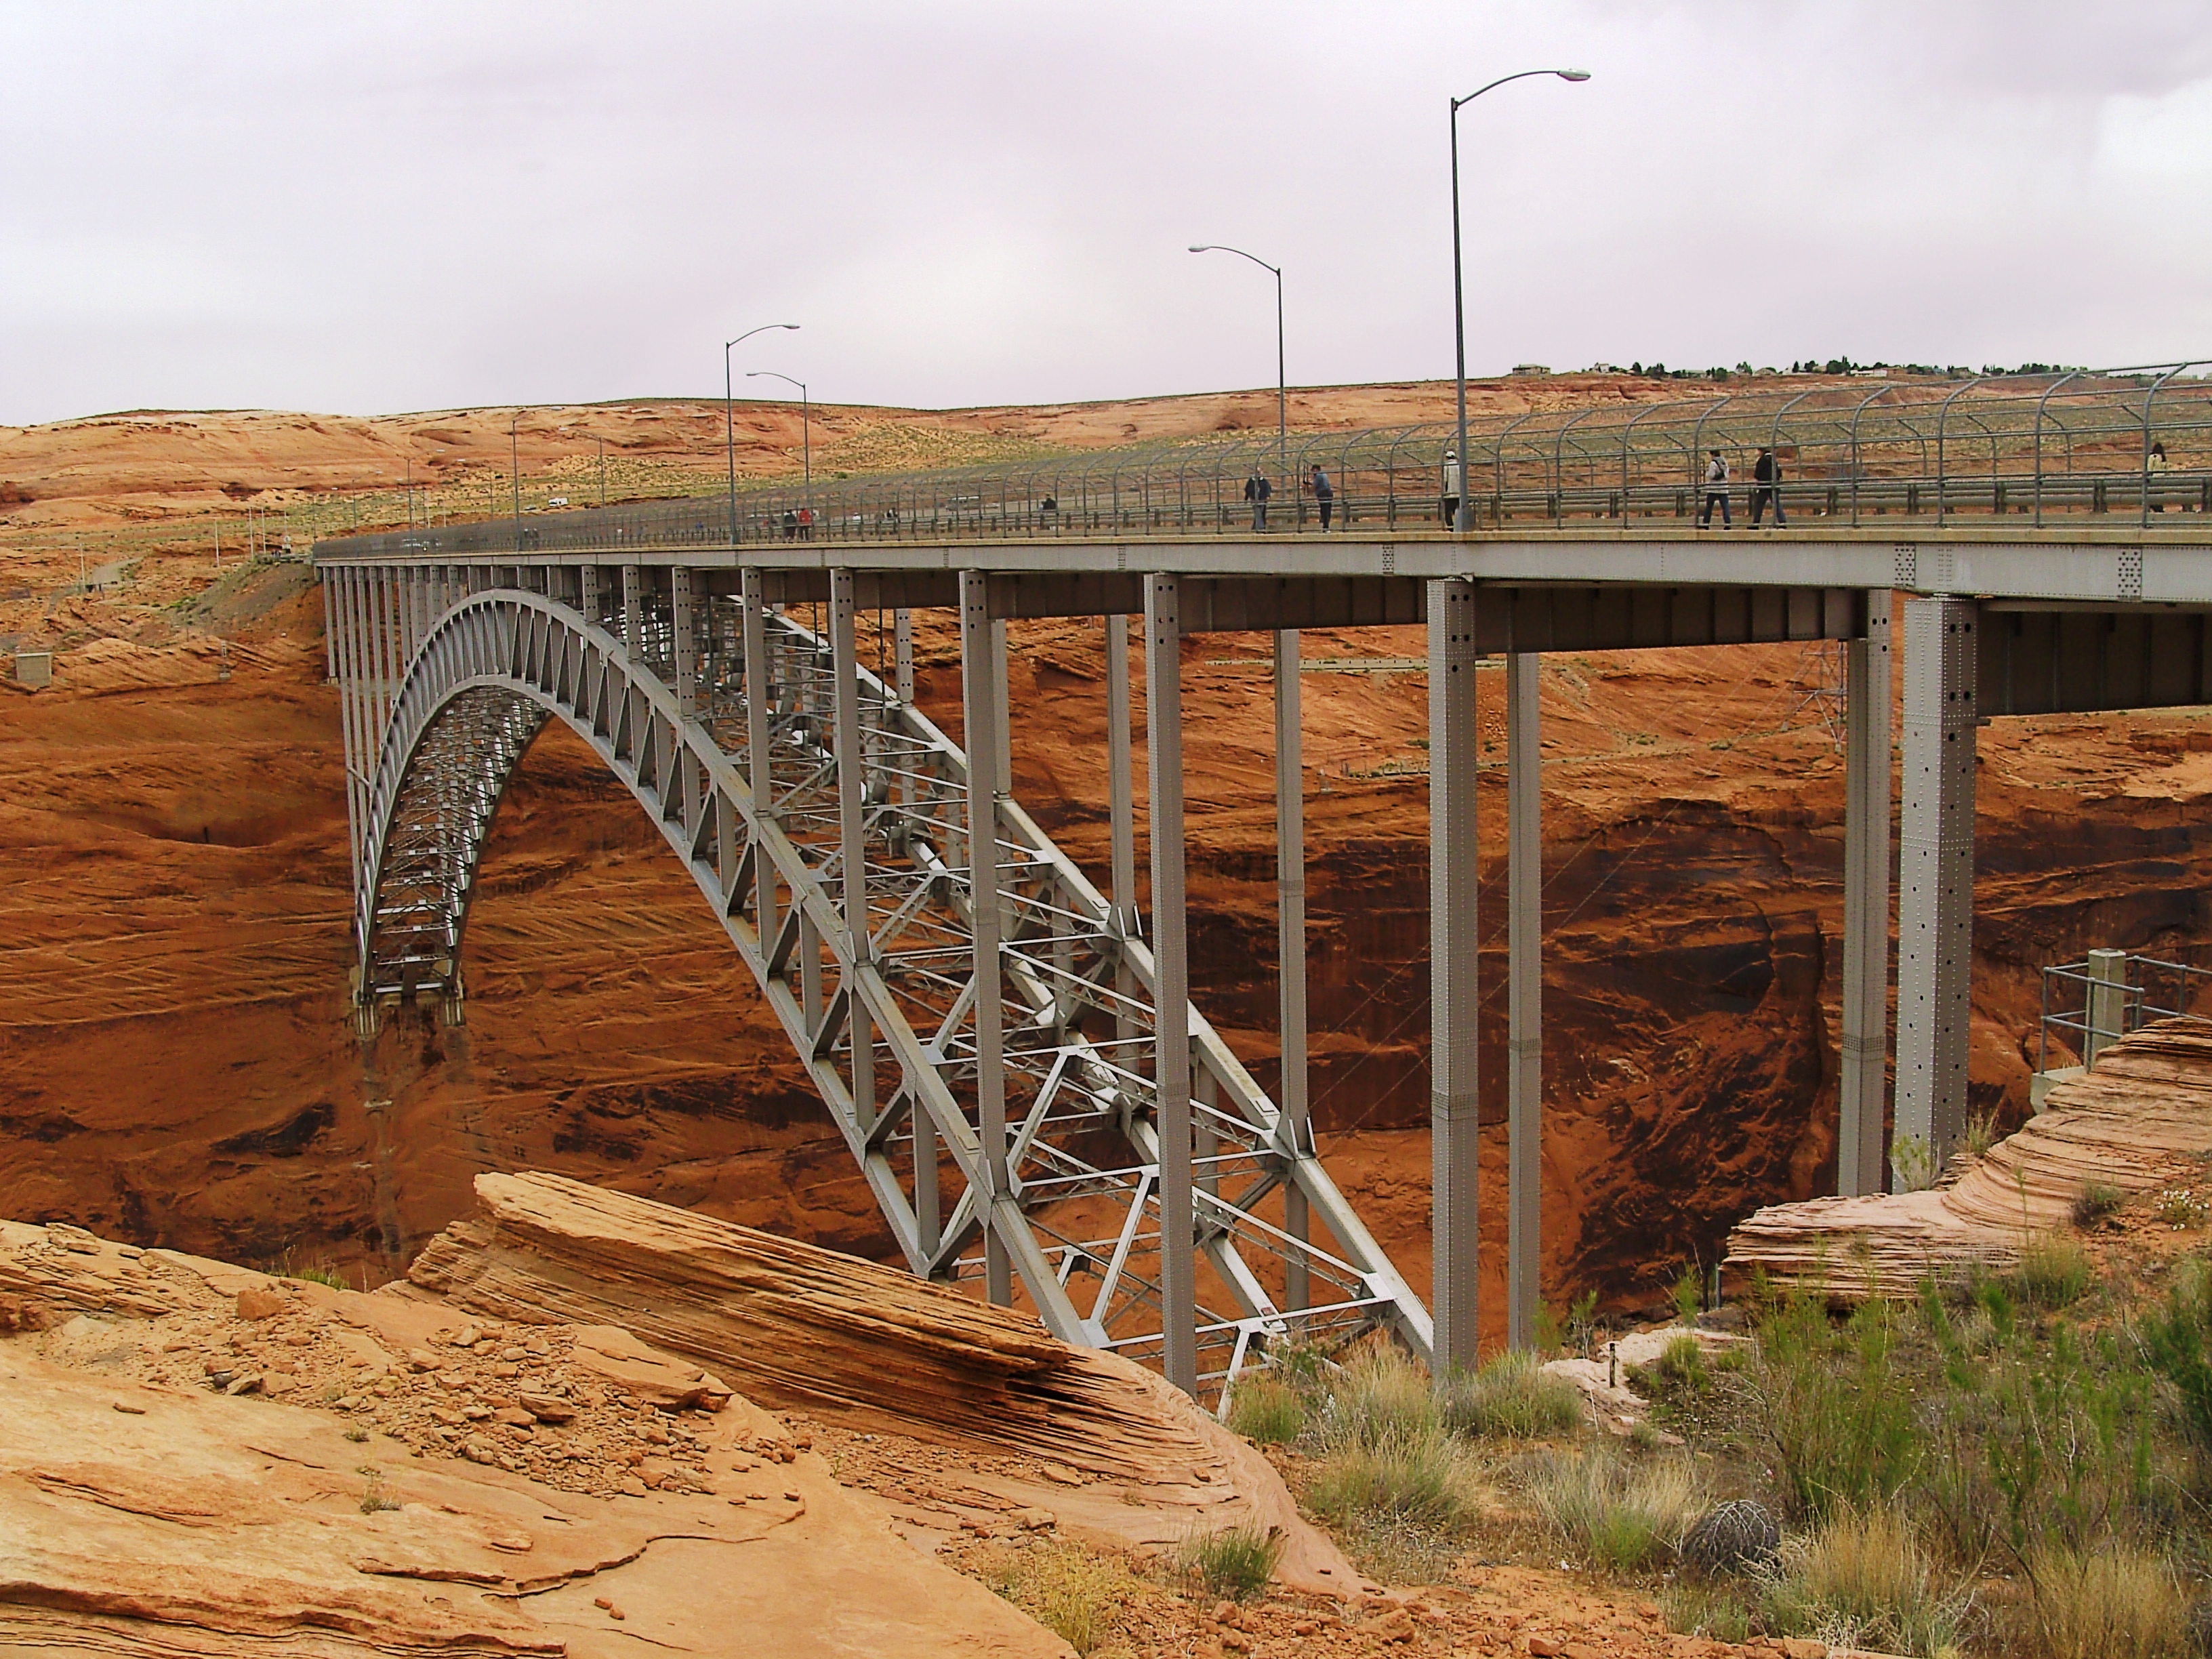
{"left": 1752, "top": 1296, "right": 1925, "bottom": 1517}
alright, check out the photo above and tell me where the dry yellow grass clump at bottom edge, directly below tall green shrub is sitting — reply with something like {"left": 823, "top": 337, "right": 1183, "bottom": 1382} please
{"left": 1759, "top": 1507, "right": 1971, "bottom": 1654}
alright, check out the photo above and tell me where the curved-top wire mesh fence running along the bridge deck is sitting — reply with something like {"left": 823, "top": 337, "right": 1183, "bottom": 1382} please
{"left": 321, "top": 359, "right": 2212, "bottom": 558}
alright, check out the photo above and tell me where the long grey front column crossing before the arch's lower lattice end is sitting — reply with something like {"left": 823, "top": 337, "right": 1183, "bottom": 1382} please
{"left": 1143, "top": 575, "right": 1199, "bottom": 1393}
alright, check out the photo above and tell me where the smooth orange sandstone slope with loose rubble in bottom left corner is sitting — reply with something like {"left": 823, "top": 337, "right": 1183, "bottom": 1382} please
{"left": 0, "top": 1223, "right": 1106, "bottom": 1659}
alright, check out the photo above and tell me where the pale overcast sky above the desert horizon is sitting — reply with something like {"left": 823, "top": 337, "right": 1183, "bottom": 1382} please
{"left": 0, "top": 0, "right": 2212, "bottom": 422}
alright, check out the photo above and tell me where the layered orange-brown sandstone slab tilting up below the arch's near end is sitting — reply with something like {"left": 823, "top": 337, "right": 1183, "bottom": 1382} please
{"left": 407, "top": 1174, "right": 1351, "bottom": 1593}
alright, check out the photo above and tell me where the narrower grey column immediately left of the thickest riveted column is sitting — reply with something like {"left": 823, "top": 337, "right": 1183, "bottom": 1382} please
{"left": 1836, "top": 588, "right": 1889, "bottom": 1197}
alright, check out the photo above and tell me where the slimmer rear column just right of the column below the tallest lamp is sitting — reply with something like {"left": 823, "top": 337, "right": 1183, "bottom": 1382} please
{"left": 1507, "top": 651, "right": 1544, "bottom": 1347}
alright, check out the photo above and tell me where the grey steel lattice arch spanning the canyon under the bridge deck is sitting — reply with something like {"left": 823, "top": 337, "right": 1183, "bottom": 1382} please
{"left": 327, "top": 571, "right": 1431, "bottom": 1380}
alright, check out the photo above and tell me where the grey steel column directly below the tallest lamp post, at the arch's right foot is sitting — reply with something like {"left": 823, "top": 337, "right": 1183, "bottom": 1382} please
{"left": 1429, "top": 579, "right": 1482, "bottom": 1380}
